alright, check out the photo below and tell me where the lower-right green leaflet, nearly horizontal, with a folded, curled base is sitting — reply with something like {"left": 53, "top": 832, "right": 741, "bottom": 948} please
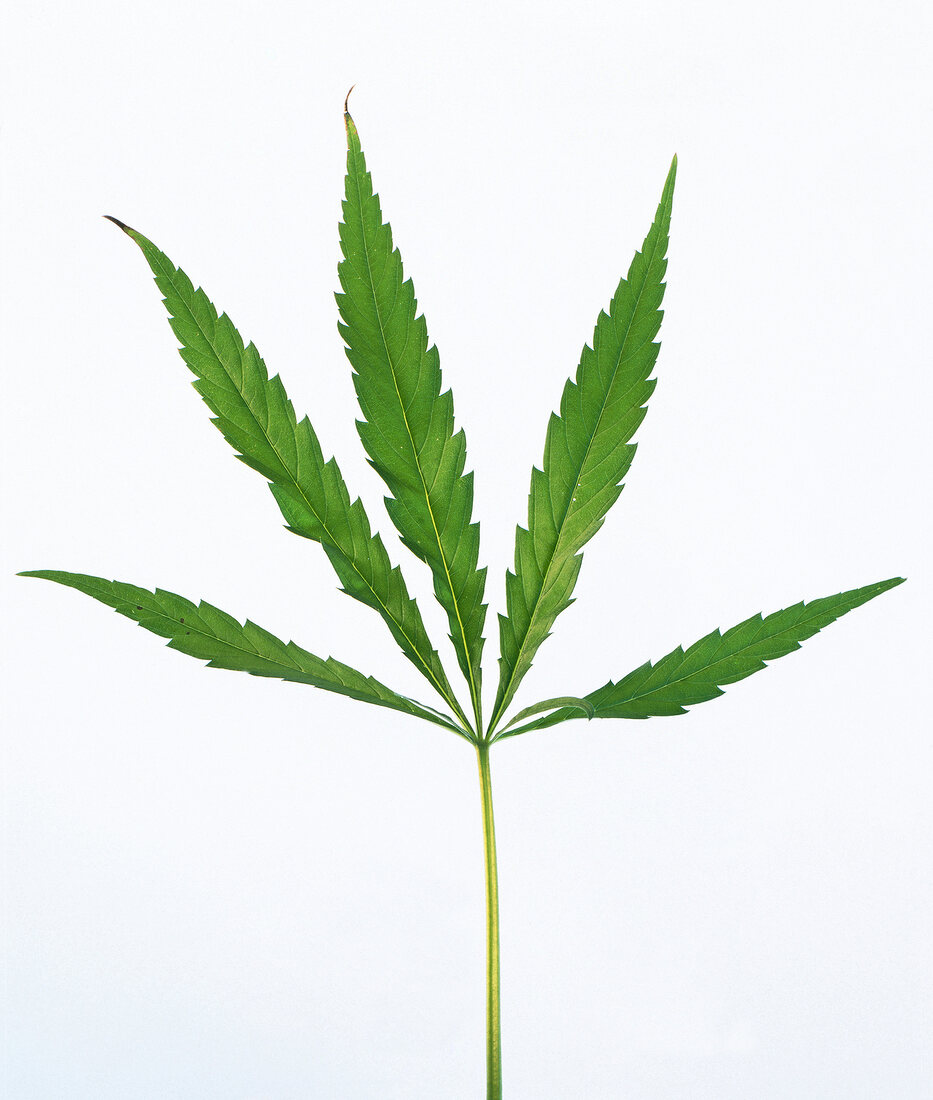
{"left": 500, "top": 576, "right": 904, "bottom": 737}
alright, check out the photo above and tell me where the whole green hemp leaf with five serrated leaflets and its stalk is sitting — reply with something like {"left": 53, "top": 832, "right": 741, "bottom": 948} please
{"left": 20, "top": 105, "right": 903, "bottom": 1100}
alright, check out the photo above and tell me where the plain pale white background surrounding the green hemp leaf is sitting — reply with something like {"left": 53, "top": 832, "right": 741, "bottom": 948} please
{"left": 0, "top": 0, "right": 933, "bottom": 1100}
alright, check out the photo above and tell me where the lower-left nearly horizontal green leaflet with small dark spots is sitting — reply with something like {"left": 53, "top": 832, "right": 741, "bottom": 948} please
{"left": 19, "top": 569, "right": 465, "bottom": 737}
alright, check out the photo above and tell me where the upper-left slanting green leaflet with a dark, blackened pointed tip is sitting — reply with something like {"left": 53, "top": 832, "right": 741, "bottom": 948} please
{"left": 110, "top": 218, "right": 465, "bottom": 724}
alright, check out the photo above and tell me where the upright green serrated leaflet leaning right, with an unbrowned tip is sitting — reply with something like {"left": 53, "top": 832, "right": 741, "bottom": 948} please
{"left": 490, "top": 157, "right": 677, "bottom": 730}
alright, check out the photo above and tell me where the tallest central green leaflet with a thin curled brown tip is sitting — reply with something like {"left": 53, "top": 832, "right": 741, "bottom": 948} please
{"left": 337, "top": 114, "right": 486, "bottom": 732}
